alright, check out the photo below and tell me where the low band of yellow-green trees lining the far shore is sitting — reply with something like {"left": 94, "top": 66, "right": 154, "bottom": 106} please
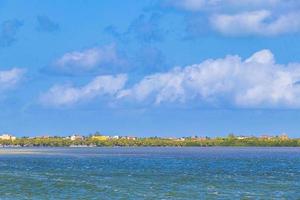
{"left": 0, "top": 135, "right": 300, "bottom": 147}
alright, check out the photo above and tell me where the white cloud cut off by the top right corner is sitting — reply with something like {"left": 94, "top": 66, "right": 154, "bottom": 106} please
{"left": 166, "top": 0, "right": 300, "bottom": 36}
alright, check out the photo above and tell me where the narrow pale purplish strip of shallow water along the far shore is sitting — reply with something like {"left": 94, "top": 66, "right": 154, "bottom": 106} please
{"left": 0, "top": 146, "right": 300, "bottom": 157}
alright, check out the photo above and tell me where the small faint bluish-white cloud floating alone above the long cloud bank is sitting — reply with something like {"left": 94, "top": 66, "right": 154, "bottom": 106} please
{"left": 53, "top": 45, "right": 123, "bottom": 73}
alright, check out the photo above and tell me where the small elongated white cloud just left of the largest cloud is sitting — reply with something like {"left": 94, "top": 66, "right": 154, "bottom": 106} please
{"left": 40, "top": 74, "right": 127, "bottom": 106}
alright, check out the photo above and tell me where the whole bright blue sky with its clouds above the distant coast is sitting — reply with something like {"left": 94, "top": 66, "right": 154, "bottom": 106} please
{"left": 0, "top": 0, "right": 300, "bottom": 137}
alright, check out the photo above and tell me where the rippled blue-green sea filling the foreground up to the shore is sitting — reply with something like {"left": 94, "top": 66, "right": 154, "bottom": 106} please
{"left": 0, "top": 147, "right": 300, "bottom": 200}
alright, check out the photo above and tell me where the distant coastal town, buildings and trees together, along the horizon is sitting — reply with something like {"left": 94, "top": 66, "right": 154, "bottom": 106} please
{"left": 0, "top": 132, "right": 300, "bottom": 147}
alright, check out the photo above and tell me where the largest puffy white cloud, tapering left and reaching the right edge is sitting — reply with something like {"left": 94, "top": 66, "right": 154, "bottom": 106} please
{"left": 118, "top": 50, "right": 300, "bottom": 108}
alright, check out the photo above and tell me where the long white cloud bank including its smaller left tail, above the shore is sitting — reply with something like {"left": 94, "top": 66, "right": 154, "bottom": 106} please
{"left": 40, "top": 49, "right": 300, "bottom": 108}
